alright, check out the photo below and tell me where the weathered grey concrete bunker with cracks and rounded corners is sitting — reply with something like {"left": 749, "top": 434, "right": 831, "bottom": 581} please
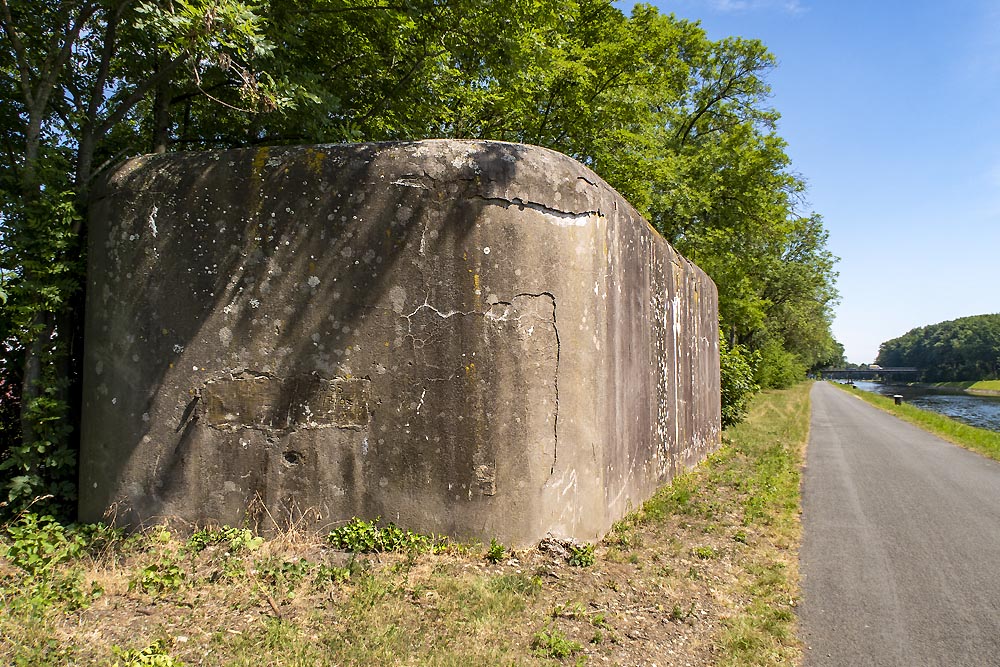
{"left": 80, "top": 141, "right": 720, "bottom": 544}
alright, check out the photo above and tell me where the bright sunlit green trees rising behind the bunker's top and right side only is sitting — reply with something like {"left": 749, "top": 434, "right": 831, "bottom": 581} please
{"left": 254, "top": 0, "right": 837, "bottom": 392}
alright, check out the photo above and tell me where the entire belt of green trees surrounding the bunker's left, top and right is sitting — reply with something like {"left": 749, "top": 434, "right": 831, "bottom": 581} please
{"left": 0, "top": 0, "right": 843, "bottom": 509}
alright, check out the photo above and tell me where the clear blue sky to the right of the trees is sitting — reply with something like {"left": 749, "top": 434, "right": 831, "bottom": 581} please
{"left": 632, "top": 0, "right": 1000, "bottom": 363}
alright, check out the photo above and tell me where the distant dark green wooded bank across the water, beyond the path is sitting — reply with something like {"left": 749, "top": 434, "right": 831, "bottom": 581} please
{"left": 875, "top": 313, "right": 1000, "bottom": 382}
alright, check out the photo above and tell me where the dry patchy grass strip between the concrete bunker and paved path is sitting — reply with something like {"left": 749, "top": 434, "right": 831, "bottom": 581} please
{"left": 0, "top": 385, "right": 809, "bottom": 667}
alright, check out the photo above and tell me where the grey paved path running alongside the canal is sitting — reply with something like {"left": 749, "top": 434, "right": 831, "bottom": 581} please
{"left": 799, "top": 382, "right": 1000, "bottom": 667}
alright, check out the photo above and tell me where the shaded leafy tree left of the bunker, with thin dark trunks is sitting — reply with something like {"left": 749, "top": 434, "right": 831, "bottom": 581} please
{"left": 0, "top": 0, "right": 296, "bottom": 507}
